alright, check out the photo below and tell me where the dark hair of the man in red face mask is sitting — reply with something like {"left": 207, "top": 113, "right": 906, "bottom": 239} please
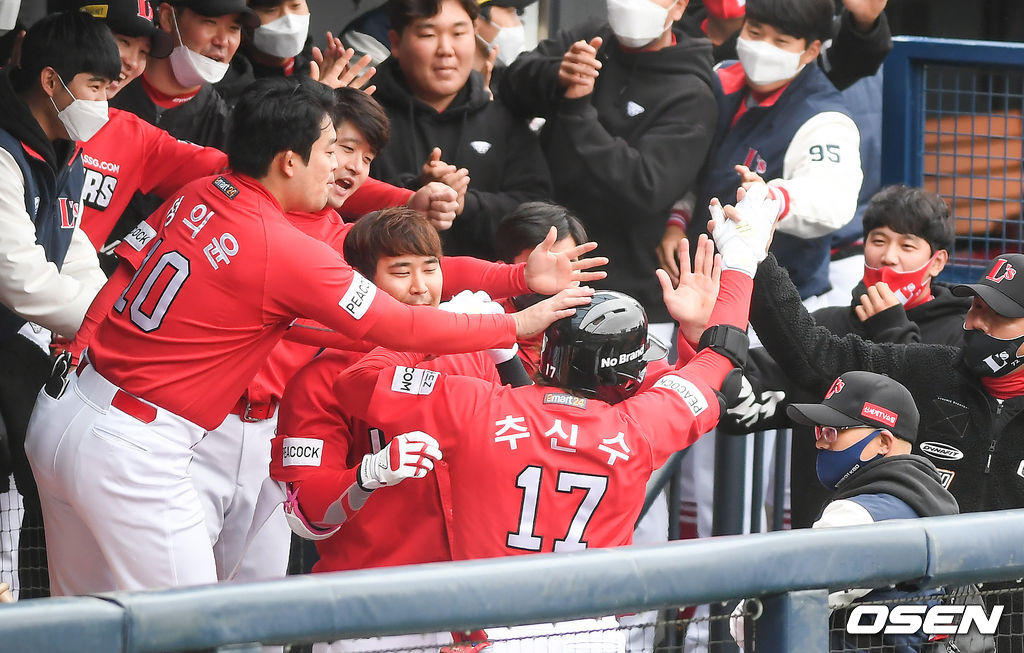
{"left": 863, "top": 184, "right": 954, "bottom": 254}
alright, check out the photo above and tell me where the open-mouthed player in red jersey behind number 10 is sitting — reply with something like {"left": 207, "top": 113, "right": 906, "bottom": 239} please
{"left": 189, "top": 88, "right": 548, "bottom": 580}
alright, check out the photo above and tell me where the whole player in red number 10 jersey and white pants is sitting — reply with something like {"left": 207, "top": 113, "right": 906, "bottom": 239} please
{"left": 24, "top": 80, "right": 599, "bottom": 594}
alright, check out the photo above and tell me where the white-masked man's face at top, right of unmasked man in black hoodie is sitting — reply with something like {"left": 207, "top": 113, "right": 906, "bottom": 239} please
{"left": 473, "top": 0, "right": 537, "bottom": 93}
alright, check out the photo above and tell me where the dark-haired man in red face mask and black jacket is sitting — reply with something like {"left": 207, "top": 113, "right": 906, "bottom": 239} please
{"left": 719, "top": 185, "right": 971, "bottom": 528}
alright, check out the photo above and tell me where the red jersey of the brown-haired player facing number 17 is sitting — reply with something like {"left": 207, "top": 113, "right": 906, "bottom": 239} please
{"left": 270, "top": 351, "right": 501, "bottom": 571}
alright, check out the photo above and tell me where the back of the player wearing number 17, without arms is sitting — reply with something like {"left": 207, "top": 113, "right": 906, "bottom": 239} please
{"left": 435, "top": 386, "right": 653, "bottom": 560}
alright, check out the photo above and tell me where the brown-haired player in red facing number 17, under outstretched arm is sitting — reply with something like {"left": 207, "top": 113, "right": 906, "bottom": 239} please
{"left": 270, "top": 209, "right": 529, "bottom": 571}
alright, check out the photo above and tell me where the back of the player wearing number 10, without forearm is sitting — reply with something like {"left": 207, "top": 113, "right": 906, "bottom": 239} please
{"left": 89, "top": 175, "right": 350, "bottom": 428}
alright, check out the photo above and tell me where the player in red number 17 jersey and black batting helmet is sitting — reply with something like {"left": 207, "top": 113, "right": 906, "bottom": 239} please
{"left": 292, "top": 186, "right": 777, "bottom": 650}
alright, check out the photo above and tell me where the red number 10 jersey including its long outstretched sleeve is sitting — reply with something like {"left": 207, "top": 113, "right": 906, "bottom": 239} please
{"left": 89, "top": 174, "right": 515, "bottom": 429}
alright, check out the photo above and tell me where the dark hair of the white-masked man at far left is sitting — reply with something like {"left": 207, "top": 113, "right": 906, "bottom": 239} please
{"left": 10, "top": 11, "right": 121, "bottom": 92}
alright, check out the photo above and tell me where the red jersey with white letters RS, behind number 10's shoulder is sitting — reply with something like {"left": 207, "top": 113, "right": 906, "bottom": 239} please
{"left": 82, "top": 108, "right": 227, "bottom": 250}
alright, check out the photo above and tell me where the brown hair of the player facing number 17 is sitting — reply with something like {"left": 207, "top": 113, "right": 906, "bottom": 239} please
{"left": 344, "top": 207, "right": 441, "bottom": 279}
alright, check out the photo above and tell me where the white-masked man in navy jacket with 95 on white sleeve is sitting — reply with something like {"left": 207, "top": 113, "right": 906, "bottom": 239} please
{"left": 677, "top": 0, "right": 863, "bottom": 307}
